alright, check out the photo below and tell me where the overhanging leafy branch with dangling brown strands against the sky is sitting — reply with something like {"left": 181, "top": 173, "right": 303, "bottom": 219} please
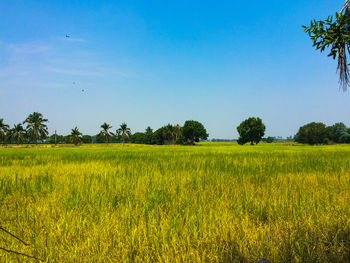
{"left": 303, "top": 0, "right": 350, "bottom": 91}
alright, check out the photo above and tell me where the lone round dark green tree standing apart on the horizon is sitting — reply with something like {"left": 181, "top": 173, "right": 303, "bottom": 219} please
{"left": 237, "top": 117, "right": 266, "bottom": 145}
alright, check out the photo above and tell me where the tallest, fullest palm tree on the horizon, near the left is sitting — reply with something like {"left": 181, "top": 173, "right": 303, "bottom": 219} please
{"left": 24, "top": 112, "right": 49, "bottom": 145}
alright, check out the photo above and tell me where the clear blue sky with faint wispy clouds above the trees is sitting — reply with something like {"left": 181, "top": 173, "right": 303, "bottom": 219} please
{"left": 0, "top": 0, "right": 350, "bottom": 139}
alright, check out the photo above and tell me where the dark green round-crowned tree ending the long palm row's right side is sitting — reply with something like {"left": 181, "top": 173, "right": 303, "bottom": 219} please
{"left": 182, "top": 120, "right": 209, "bottom": 144}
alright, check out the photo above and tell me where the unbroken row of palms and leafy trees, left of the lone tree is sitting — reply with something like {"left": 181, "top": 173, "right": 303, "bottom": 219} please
{"left": 0, "top": 112, "right": 209, "bottom": 145}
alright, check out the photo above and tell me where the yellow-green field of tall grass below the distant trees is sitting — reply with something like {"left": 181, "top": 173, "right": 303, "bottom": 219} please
{"left": 0, "top": 143, "right": 350, "bottom": 262}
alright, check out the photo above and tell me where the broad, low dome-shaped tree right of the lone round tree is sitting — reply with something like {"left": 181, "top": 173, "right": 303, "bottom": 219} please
{"left": 295, "top": 122, "right": 332, "bottom": 145}
